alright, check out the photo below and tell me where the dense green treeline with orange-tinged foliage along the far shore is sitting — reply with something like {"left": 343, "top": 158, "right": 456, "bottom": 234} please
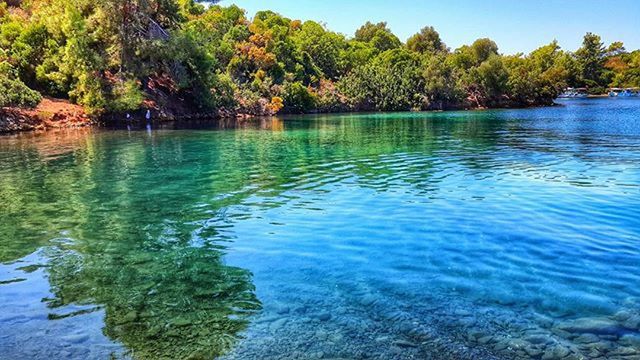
{"left": 0, "top": 0, "right": 640, "bottom": 114}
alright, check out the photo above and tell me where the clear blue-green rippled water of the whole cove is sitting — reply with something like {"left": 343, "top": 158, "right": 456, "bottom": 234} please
{"left": 0, "top": 99, "right": 640, "bottom": 359}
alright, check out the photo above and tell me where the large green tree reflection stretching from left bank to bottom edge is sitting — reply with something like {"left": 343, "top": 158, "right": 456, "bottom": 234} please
{"left": 0, "top": 130, "right": 261, "bottom": 359}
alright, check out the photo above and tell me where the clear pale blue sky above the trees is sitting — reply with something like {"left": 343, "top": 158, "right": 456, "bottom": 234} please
{"left": 222, "top": 0, "right": 640, "bottom": 54}
